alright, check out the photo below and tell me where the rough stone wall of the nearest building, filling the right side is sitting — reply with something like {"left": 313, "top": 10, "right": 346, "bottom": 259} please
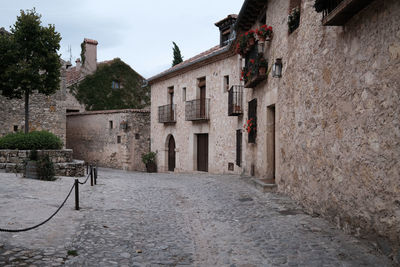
{"left": 246, "top": 0, "right": 400, "bottom": 262}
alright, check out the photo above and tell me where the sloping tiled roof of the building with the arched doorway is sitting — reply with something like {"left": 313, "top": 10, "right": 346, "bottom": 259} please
{"left": 148, "top": 45, "right": 230, "bottom": 83}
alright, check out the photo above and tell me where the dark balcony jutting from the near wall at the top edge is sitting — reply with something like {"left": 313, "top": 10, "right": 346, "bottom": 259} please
{"left": 315, "top": 0, "right": 372, "bottom": 26}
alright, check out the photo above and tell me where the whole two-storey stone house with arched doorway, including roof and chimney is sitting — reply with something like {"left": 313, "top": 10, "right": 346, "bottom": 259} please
{"left": 148, "top": 15, "right": 242, "bottom": 173}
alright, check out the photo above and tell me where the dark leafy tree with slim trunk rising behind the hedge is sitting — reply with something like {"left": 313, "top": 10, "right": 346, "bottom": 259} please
{"left": 0, "top": 9, "right": 61, "bottom": 133}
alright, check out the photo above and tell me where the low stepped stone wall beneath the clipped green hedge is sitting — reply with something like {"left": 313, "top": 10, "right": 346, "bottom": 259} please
{"left": 0, "top": 149, "right": 85, "bottom": 177}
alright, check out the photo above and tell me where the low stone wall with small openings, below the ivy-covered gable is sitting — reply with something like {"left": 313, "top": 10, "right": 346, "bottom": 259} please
{"left": 67, "top": 109, "right": 150, "bottom": 171}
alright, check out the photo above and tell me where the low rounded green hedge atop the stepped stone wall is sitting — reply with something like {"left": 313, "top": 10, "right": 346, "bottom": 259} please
{"left": 0, "top": 131, "right": 63, "bottom": 150}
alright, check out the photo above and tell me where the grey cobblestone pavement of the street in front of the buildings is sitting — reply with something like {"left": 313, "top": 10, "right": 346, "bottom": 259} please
{"left": 0, "top": 169, "right": 392, "bottom": 267}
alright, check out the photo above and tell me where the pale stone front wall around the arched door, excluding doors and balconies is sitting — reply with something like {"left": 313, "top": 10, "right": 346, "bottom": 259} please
{"left": 151, "top": 56, "right": 244, "bottom": 174}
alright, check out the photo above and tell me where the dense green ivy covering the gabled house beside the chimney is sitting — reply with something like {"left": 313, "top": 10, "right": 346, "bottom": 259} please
{"left": 71, "top": 58, "right": 150, "bottom": 110}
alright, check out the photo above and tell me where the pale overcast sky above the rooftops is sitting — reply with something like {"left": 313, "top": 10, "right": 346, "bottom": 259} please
{"left": 0, "top": 0, "right": 244, "bottom": 78}
